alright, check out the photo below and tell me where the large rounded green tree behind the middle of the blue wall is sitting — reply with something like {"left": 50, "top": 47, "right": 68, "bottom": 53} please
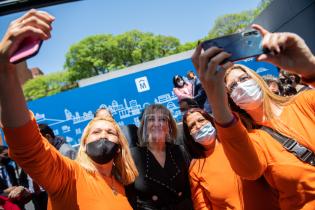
{"left": 65, "top": 30, "right": 180, "bottom": 81}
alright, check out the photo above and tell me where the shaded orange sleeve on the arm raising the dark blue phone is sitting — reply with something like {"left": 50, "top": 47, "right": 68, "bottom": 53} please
{"left": 216, "top": 119, "right": 267, "bottom": 180}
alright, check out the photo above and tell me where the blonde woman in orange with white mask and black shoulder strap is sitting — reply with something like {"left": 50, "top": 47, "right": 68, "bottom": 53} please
{"left": 193, "top": 25, "right": 315, "bottom": 210}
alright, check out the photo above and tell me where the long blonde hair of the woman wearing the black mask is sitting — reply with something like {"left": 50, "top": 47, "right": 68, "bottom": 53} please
{"left": 76, "top": 117, "right": 138, "bottom": 185}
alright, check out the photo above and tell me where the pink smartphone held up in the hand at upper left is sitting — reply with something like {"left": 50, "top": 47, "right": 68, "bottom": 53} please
{"left": 10, "top": 37, "right": 43, "bottom": 64}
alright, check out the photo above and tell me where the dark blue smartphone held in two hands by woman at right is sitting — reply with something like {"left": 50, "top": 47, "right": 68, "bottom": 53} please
{"left": 202, "top": 30, "right": 267, "bottom": 63}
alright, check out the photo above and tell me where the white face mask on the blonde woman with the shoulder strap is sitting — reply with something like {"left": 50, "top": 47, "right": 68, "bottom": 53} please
{"left": 231, "top": 79, "right": 263, "bottom": 111}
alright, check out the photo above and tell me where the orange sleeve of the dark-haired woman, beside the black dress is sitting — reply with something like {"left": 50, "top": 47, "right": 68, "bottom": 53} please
{"left": 189, "top": 167, "right": 212, "bottom": 210}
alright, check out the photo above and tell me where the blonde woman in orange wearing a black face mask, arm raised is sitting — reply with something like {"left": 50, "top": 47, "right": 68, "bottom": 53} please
{"left": 0, "top": 10, "right": 137, "bottom": 210}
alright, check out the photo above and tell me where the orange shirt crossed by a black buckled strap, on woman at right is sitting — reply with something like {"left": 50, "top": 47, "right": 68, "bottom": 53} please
{"left": 217, "top": 90, "right": 315, "bottom": 210}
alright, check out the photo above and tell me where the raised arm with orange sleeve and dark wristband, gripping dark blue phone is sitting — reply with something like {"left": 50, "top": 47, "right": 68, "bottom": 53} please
{"left": 192, "top": 42, "right": 266, "bottom": 179}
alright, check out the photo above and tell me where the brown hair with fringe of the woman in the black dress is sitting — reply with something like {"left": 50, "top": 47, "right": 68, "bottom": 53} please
{"left": 138, "top": 104, "right": 177, "bottom": 147}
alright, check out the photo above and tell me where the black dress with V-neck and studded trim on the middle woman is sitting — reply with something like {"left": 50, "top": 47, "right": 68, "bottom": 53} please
{"left": 126, "top": 143, "right": 193, "bottom": 210}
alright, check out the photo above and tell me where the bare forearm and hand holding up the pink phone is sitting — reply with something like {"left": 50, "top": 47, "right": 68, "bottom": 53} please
{"left": 0, "top": 10, "right": 54, "bottom": 128}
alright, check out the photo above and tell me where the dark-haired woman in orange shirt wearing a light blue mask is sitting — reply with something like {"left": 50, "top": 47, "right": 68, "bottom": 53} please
{"left": 183, "top": 108, "right": 279, "bottom": 210}
